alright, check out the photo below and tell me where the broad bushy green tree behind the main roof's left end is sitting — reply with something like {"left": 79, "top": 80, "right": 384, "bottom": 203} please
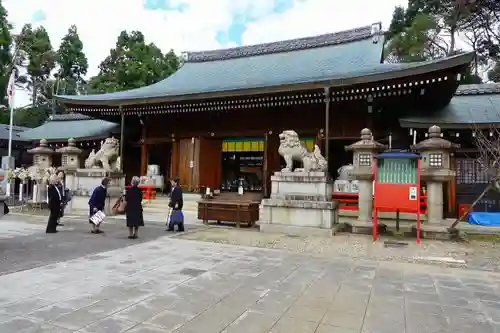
{"left": 87, "top": 31, "right": 179, "bottom": 93}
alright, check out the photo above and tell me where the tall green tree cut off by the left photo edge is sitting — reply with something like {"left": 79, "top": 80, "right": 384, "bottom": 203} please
{"left": 0, "top": 0, "right": 12, "bottom": 107}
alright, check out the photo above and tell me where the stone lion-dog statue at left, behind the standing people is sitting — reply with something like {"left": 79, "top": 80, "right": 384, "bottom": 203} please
{"left": 85, "top": 137, "right": 121, "bottom": 171}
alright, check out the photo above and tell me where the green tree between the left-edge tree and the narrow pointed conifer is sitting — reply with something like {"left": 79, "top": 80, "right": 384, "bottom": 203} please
{"left": 17, "top": 24, "right": 55, "bottom": 107}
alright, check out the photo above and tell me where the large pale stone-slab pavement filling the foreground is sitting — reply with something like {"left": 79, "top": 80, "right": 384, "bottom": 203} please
{"left": 0, "top": 233, "right": 500, "bottom": 333}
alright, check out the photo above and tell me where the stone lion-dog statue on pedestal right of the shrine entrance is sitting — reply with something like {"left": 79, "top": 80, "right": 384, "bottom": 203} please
{"left": 278, "top": 130, "right": 328, "bottom": 172}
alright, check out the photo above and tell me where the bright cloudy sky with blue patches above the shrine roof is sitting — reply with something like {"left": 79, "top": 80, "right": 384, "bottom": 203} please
{"left": 2, "top": 0, "right": 406, "bottom": 104}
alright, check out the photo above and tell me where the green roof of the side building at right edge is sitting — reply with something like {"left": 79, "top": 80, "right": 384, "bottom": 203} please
{"left": 399, "top": 84, "right": 500, "bottom": 129}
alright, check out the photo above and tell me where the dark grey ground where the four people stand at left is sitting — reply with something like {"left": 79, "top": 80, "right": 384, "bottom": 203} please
{"left": 0, "top": 215, "right": 203, "bottom": 274}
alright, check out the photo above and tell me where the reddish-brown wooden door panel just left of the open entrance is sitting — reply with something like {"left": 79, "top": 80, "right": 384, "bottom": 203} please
{"left": 198, "top": 137, "right": 222, "bottom": 189}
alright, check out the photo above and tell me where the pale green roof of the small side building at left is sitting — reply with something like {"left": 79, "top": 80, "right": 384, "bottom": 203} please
{"left": 19, "top": 114, "right": 119, "bottom": 141}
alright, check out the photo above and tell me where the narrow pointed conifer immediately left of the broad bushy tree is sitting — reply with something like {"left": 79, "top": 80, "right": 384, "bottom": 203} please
{"left": 56, "top": 25, "right": 89, "bottom": 95}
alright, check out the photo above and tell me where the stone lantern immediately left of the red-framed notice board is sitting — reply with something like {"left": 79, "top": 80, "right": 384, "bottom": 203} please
{"left": 345, "top": 128, "right": 387, "bottom": 222}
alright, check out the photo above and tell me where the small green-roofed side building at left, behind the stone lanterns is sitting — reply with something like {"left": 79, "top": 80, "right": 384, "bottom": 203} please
{"left": 19, "top": 113, "right": 120, "bottom": 166}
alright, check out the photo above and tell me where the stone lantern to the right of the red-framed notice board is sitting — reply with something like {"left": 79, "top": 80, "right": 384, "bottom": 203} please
{"left": 411, "top": 125, "right": 460, "bottom": 224}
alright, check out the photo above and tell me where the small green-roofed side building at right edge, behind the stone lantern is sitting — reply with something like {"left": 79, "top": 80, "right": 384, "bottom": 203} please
{"left": 399, "top": 83, "right": 500, "bottom": 213}
